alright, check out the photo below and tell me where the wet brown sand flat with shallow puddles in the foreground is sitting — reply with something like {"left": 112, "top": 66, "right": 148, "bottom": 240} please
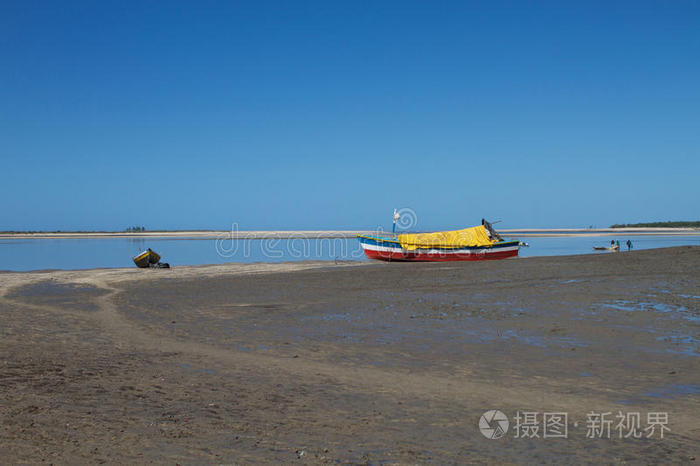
{"left": 0, "top": 247, "right": 700, "bottom": 464}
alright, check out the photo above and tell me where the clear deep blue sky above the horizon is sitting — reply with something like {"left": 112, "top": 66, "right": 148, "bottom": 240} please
{"left": 0, "top": 0, "right": 700, "bottom": 230}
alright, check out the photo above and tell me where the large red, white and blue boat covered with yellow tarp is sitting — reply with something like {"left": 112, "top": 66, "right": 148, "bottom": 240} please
{"left": 357, "top": 220, "right": 520, "bottom": 261}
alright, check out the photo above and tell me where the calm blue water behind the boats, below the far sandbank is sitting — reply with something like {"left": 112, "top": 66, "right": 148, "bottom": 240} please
{"left": 0, "top": 236, "right": 700, "bottom": 271}
